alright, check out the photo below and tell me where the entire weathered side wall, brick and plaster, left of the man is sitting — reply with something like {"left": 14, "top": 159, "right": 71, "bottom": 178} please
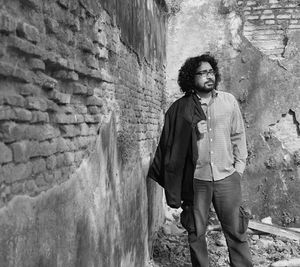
{"left": 0, "top": 0, "right": 165, "bottom": 267}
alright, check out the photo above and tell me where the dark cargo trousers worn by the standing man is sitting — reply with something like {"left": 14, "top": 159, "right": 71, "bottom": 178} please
{"left": 180, "top": 172, "right": 253, "bottom": 267}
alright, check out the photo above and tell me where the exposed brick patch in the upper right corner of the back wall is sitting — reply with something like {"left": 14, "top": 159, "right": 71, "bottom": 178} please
{"left": 238, "top": 0, "right": 300, "bottom": 59}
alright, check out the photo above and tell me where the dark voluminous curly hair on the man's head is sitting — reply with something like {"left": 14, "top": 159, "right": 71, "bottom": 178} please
{"left": 177, "top": 53, "right": 221, "bottom": 94}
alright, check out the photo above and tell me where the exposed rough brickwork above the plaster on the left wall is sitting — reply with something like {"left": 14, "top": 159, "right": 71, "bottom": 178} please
{"left": 0, "top": 0, "right": 164, "bottom": 211}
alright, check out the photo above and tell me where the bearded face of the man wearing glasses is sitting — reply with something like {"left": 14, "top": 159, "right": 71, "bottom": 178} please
{"left": 195, "top": 62, "right": 216, "bottom": 93}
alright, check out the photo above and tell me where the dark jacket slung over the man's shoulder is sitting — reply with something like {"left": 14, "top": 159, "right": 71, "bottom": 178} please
{"left": 148, "top": 94, "right": 206, "bottom": 208}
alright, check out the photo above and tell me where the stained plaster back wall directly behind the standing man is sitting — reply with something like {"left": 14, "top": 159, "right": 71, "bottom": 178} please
{"left": 167, "top": 0, "right": 300, "bottom": 225}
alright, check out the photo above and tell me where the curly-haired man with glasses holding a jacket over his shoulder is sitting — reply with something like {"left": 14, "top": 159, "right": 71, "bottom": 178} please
{"left": 149, "top": 54, "right": 253, "bottom": 267}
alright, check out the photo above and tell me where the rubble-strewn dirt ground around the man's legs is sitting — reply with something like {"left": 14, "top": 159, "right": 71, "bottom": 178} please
{"left": 150, "top": 210, "right": 300, "bottom": 267}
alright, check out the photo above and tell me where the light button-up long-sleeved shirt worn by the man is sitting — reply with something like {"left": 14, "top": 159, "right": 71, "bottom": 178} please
{"left": 194, "top": 90, "right": 247, "bottom": 181}
